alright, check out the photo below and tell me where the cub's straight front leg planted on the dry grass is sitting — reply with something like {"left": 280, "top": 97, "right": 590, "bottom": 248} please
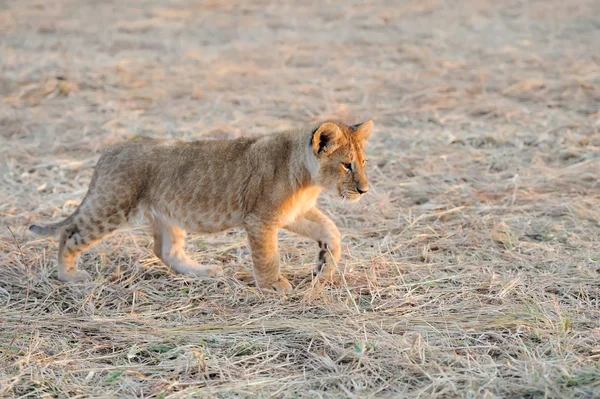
{"left": 245, "top": 224, "right": 292, "bottom": 294}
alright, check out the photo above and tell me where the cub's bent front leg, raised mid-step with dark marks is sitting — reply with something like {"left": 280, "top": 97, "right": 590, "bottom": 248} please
{"left": 285, "top": 207, "right": 342, "bottom": 280}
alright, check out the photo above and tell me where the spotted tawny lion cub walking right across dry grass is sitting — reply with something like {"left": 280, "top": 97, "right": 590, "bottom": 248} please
{"left": 29, "top": 121, "right": 373, "bottom": 293}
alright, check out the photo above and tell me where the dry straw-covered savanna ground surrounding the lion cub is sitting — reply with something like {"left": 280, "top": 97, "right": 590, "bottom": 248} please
{"left": 0, "top": 0, "right": 600, "bottom": 398}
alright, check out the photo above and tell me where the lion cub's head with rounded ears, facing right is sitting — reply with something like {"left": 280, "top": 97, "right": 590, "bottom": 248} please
{"left": 312, "top": 121, "right": 373, "bottom": 202}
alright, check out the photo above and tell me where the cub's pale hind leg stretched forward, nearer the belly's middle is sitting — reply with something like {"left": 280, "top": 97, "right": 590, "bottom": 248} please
{"left": 152, "top": 220, "right": 223, "bottom": 277}
